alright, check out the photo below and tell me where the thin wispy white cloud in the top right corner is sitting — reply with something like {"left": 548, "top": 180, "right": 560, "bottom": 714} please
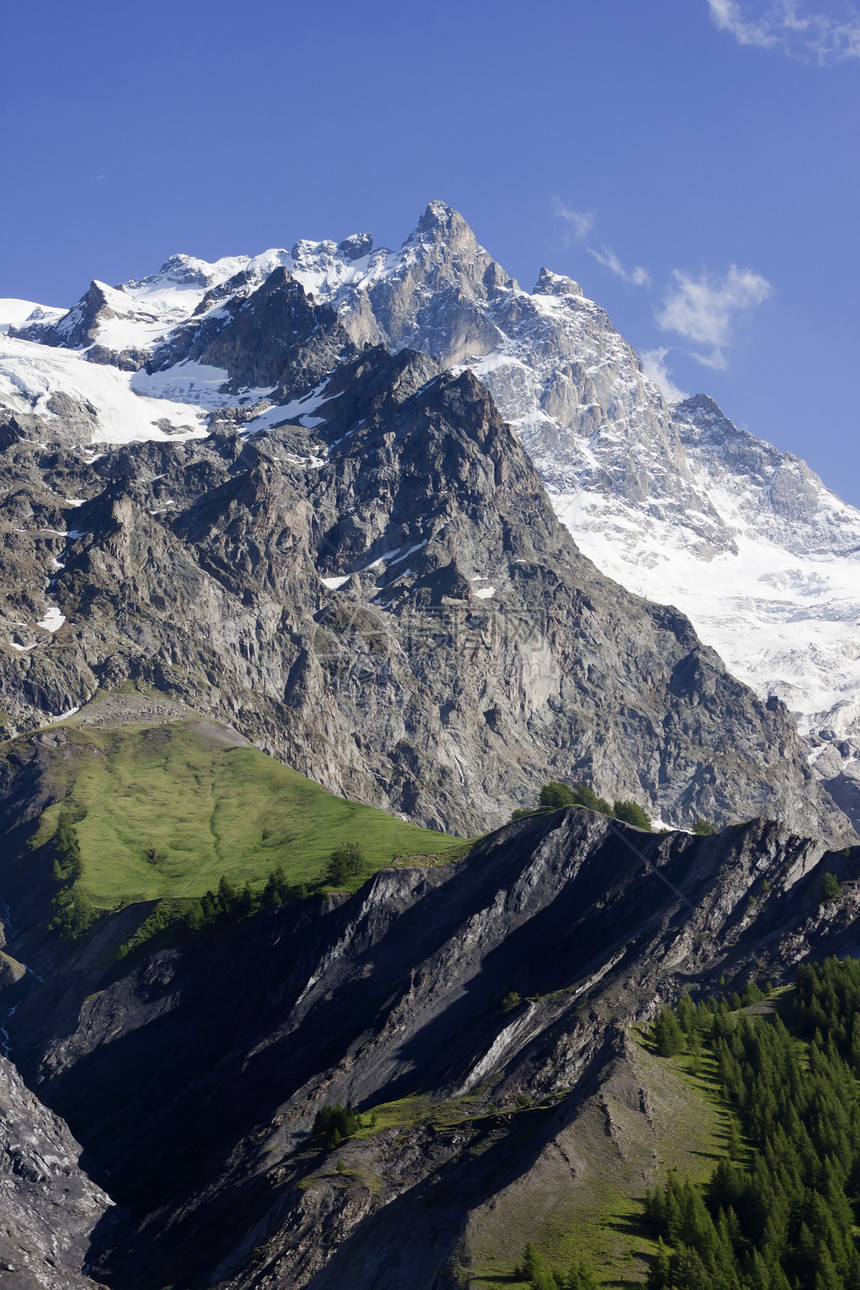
{"left": 708, "top": 0, "right": 860, "bottom": 65}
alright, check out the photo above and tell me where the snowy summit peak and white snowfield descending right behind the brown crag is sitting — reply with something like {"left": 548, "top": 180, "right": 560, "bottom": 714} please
{"left": 241, "top": 203, "right": 860, "bottom": 794}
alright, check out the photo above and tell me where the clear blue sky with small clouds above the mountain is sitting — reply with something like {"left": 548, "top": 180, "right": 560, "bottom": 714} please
{"left": 0, "top": 0, "right": 860, "bottom": 504}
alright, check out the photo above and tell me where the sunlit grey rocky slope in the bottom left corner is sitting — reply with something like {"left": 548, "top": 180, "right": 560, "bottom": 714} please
{"left": 0, "top": 1057, "right": 119, "bottom": 1290}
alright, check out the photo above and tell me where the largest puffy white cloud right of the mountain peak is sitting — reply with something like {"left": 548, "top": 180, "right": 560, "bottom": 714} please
{"left": 655, "top": 264, "right": 774, "bottom": 369}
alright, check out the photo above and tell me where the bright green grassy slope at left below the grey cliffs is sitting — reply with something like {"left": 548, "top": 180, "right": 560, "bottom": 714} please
{"left": 25, "top": 722, "right": 455, "bottom": 908}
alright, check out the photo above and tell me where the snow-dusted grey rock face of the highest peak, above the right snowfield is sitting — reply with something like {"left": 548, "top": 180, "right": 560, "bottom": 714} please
{"left": 279, "top": 201, "right": 731, "bottom": 550}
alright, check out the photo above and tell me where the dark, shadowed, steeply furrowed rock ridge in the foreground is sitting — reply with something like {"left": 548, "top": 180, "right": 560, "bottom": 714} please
{"left": 1, "top": 811, "right": 860, "bottom": 1290}
